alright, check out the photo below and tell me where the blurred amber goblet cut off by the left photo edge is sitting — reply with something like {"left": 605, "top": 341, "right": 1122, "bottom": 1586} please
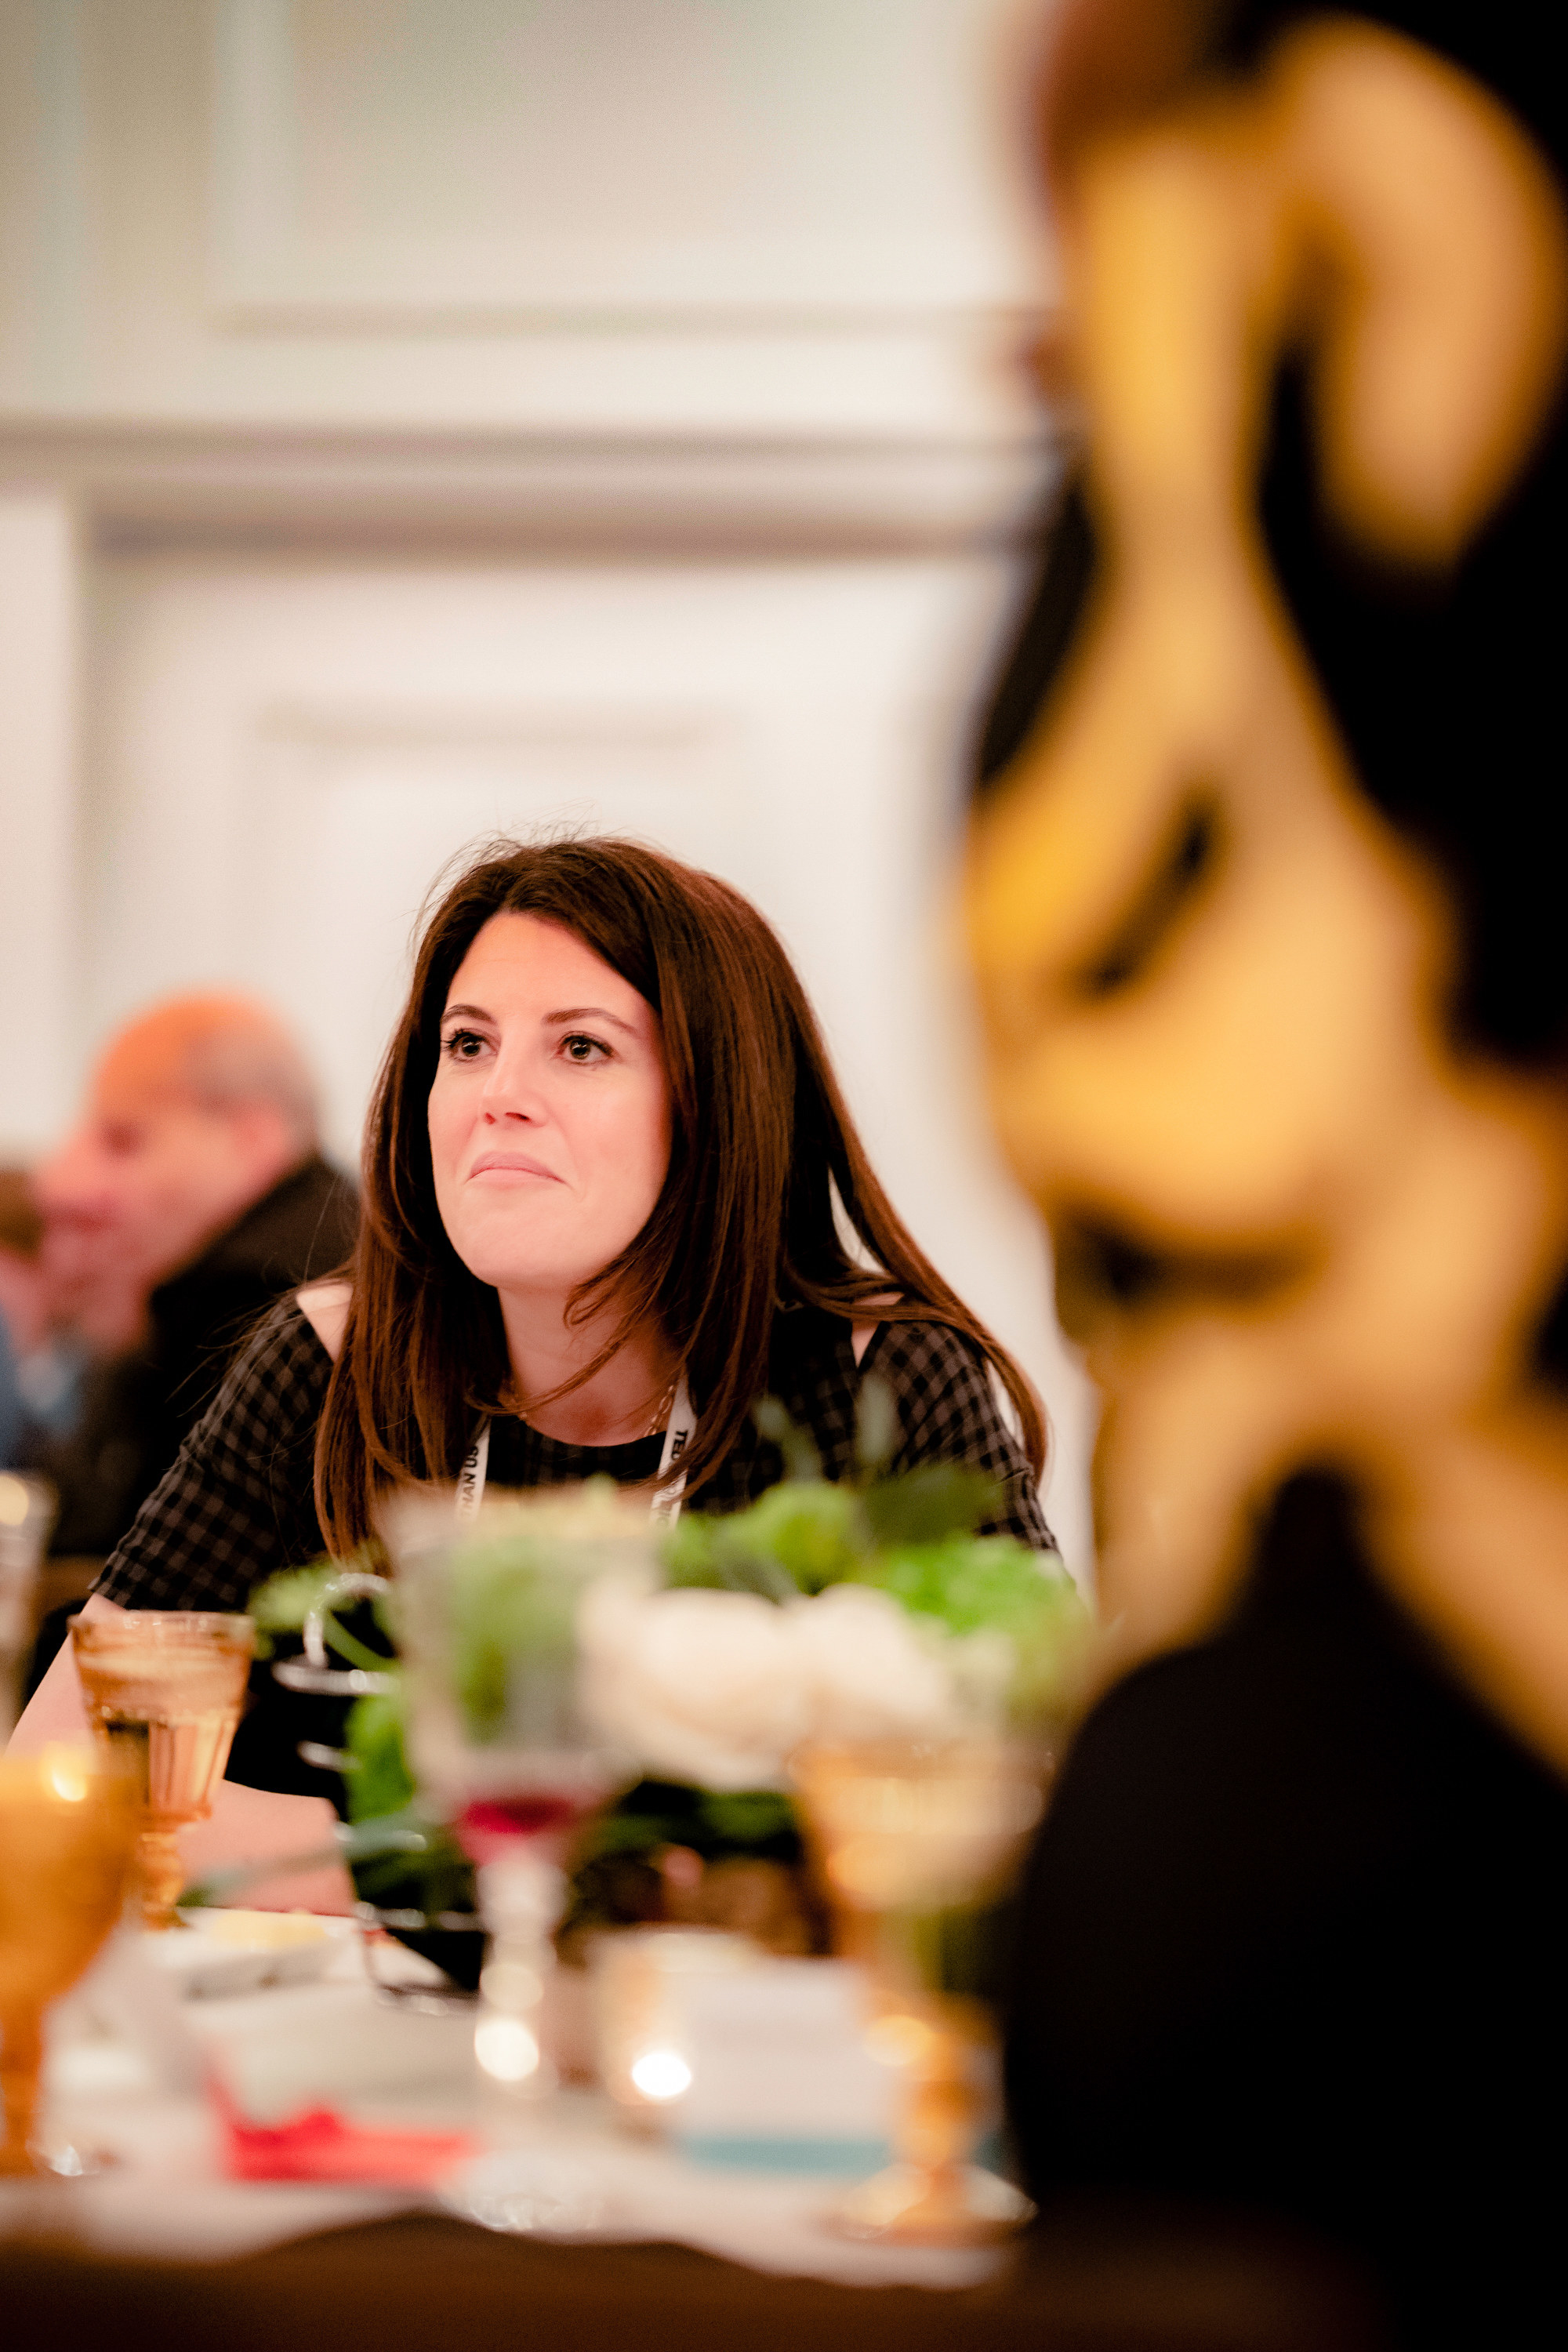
{"left": 0, "top": 1743, "right": 136, "bottom": 2173}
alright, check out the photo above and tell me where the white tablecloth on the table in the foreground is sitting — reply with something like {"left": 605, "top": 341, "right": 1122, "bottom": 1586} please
{"left": 0, "top": 1940, "right": 1004, "bottom": 2288}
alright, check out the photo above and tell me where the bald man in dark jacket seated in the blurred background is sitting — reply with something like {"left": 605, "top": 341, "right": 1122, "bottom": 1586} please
{"left": 35, "top": 995, "right": 358, "bottom": 1557}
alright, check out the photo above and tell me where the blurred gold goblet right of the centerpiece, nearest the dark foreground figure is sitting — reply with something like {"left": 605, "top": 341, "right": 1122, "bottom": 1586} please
{"left": 792, "top": 1736, "right": 1046, "bottom": 2246}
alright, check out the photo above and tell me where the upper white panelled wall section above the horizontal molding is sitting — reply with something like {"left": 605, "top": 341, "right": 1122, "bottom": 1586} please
{"left": 0, "top": 0, "right": 1051, "bottom": 435}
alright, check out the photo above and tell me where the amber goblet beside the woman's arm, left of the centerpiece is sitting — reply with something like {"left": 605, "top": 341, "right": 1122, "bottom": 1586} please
{"left": 71, "top": 1609, "right": 256, "bottom": 1929}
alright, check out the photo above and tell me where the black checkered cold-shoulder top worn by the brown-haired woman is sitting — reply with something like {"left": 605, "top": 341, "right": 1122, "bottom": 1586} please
{"left": 96, "top": 1298, "right": 1051, "bottom": 1609}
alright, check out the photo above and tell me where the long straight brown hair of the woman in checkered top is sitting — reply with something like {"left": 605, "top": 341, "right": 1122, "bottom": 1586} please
{"left": 315, "top": 840, "right": 1044, "bottom": 1557}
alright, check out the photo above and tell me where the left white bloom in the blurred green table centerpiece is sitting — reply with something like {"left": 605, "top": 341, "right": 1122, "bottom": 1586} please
{"left": 579, "top": 1578, "right": 811, "bottom": 1790}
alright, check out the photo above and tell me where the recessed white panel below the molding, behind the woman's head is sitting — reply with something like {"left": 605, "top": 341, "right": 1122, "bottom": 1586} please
{"left": 85, "top": 555, "right": 1004, "bottom": 1176}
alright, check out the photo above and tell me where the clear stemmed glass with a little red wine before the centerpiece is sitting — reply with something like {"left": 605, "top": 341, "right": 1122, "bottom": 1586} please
{"left": 386, "top": 1489, "right": 656, "bottom": 2096}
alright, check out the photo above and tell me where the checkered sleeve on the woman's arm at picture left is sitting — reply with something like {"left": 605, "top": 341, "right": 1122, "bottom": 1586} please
{"left": 94, "top": 1298, "right": 332, "bottom": 1611}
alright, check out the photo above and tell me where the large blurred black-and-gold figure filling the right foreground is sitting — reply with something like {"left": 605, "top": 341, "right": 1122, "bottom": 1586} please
{"left": 968, "top": 0, "right": 1568, "bottom": 2345}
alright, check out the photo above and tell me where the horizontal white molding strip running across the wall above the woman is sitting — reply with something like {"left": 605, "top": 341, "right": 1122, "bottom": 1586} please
{"left": 0, "top": 419, "right": 1060, "bottom": 555}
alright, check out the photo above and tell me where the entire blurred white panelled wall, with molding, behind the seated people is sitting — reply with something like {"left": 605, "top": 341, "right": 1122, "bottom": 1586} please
{"left": 0, "top": 0, "right": 1091, "bottom": 1569}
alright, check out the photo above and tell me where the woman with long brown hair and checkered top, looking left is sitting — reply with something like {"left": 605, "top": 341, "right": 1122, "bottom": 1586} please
{"left": 15, "top": 840, "right": 1051, "bottom": 1816}
